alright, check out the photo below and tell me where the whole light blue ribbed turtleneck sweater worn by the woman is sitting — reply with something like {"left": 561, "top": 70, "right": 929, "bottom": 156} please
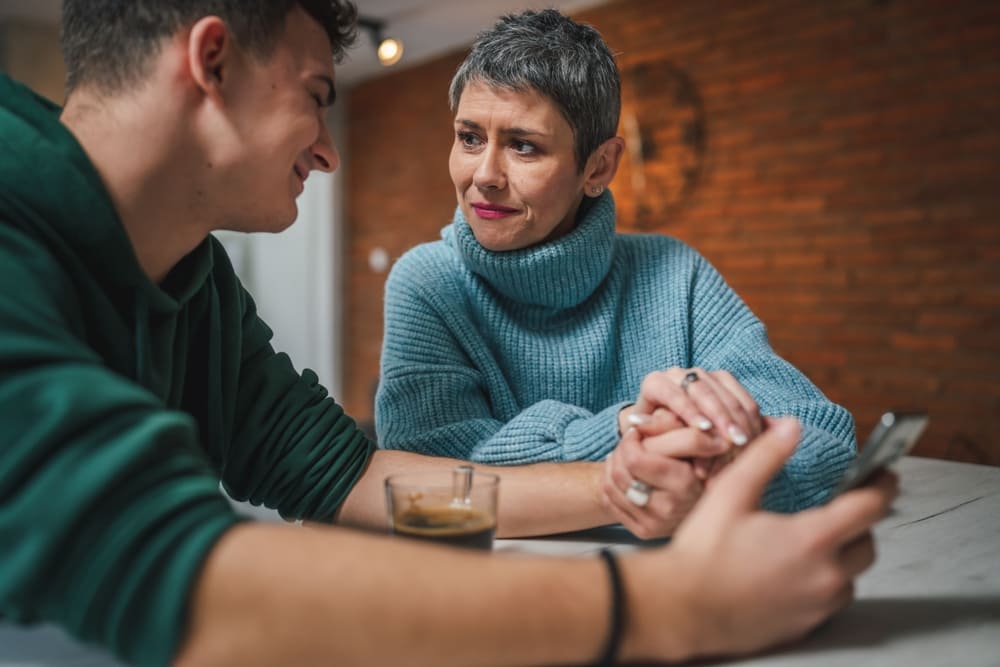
{"left": 375, "top": 192, "right": 855, "bottom": 511}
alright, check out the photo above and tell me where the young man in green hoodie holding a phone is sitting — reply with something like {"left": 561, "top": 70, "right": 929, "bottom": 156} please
{"left": 0, "top": 0, "right": 894, "bottom": 666}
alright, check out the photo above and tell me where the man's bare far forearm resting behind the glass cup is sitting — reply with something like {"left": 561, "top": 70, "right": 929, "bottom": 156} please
{"left": 338, "top": 450, "right": 615, "bottom": 537}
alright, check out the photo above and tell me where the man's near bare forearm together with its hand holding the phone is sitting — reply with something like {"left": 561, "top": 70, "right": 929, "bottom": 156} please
{"left": 177, "top": 420, "right": 897, "bottom": 667}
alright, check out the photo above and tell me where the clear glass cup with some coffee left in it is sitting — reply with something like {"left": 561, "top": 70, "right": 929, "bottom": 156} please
{"left": 385, "top": 465, "right": 500, "bottom": 551}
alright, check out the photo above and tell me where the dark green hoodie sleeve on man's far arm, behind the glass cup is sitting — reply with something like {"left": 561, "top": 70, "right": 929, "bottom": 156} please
{"left": 207, "top": 260, "right": 375, "bottom": 521}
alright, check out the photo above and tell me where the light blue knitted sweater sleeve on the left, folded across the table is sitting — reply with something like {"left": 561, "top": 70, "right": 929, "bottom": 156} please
{"left": 375, "top": 250, "right": 625, "bottom": 465}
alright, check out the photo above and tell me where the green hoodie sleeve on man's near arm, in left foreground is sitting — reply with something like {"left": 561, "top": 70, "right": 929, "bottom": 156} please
{"left": 0, "top": 225, "right": 239, "bottom": 666}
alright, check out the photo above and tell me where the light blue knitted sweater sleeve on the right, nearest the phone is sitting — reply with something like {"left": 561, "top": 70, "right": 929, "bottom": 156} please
{"left": 691, "top": 250, "right": 856, "bottom": 512}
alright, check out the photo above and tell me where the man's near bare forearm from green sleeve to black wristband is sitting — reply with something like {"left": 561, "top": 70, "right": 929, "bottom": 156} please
{"left": 177, "top": 524, "right": 610, "bottom": 667}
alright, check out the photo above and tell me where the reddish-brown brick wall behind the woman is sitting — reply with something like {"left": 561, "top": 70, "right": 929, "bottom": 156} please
{"left": 343, "top": 0, "right": 1000, "bottom": 464}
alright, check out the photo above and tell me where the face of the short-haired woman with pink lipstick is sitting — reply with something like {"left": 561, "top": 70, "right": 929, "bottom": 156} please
{"left": 448, "top": 82, "right": 586, "bottom": 251}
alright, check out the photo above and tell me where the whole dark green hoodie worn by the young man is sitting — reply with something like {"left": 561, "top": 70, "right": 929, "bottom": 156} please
{"left": 0, "top": 76, "right": 373, "bottom": 665}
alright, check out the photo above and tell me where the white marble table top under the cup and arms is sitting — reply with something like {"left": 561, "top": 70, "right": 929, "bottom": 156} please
{"left": 0, "top": 457, "right": 1000, "bottom": 667}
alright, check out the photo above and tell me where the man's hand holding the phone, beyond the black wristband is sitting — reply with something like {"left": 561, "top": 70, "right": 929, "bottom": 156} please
{"left": 628, "top": 419, "right": 897, "bottom": 659}
